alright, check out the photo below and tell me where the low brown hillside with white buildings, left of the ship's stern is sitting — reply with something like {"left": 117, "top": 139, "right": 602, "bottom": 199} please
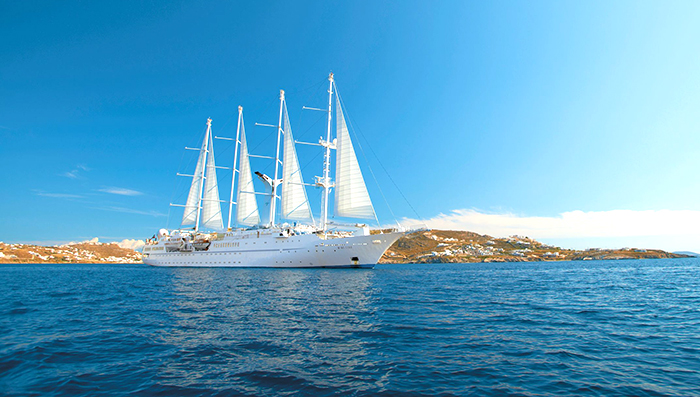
{"left": 0, "top": 239, "right": 141, "bottom": 263}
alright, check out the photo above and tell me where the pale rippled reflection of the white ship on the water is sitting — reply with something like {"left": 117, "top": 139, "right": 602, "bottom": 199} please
{"left": 159, "top": 268, "right": 377, "bottom": 383}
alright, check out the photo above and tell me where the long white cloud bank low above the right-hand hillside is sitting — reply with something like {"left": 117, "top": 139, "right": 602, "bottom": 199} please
{"left": 402, "top": 209, "right": 700, "bottom": 250}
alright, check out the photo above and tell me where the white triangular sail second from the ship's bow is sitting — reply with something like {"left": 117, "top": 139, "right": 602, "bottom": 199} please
{"left": 282, "top": 106, "right": 311, "bottom": 220}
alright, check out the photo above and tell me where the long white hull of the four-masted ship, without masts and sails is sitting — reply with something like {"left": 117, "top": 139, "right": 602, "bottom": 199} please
{"left": 143, "top": 229, "right": 404, "bottom": 268}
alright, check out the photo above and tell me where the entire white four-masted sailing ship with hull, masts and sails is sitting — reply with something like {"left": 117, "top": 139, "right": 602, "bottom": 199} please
{"left": 143, "top": 73, "right": 405, "bottom": 268}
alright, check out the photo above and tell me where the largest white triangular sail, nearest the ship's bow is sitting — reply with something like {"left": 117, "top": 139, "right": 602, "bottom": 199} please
{"left": 335, "top": 96, "right": 375, "bottom": 219}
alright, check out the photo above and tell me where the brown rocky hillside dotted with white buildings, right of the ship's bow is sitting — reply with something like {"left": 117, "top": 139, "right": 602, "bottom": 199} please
{"left": 379, "top": 230, "right": 687, "bottom": 263}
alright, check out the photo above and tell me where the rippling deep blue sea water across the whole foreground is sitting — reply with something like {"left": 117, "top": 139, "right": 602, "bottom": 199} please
{"left": 0, "top": 259, "right": 700, "bottom": 396}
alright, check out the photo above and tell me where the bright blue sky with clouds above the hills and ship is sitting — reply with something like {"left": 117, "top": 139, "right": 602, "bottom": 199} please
{"left": 0, "top": 1, "right": 700, "bottom": 251}
